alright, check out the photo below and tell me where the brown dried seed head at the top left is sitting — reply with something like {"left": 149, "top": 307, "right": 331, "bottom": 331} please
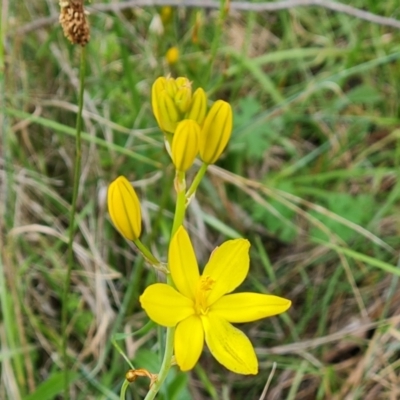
{"left": 59, "top": 0, "right": 90, "bottom": 46}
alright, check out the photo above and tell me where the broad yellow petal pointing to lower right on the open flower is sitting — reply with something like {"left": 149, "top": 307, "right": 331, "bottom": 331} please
{"left": 201, "top": 312, "right": 258, "bottom": 375}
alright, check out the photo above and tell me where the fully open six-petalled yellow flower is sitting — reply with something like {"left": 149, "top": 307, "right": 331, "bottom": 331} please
{"left": 140, "top": 226, "right": 291, "bottom": 374}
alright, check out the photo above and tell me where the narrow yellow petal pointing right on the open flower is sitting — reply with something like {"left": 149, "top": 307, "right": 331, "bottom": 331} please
{"left": 212, "top": 293, "right": 291, "bottom": 323}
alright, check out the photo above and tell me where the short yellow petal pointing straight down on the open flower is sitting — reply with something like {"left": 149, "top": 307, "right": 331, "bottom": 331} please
{"left": 174, "top": 315, "right": 204, "bottom": 371}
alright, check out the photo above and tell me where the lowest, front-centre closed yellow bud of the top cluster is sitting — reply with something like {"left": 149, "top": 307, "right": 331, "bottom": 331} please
{"left": 171, "top": 119, "right": 200, "bottom": 172}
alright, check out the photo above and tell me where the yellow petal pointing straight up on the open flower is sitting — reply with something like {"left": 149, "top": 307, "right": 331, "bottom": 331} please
{"left": 168, "top": 226, "right": 200, "bottom": 300}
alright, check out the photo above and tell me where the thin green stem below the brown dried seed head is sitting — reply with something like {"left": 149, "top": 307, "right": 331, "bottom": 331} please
{"left": 61, "top": 47, "right": 86, "bottom": 400}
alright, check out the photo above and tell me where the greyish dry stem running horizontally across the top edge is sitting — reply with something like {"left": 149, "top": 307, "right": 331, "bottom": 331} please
{"left": 14, "top": 0, "right": 400, "bottom": 35}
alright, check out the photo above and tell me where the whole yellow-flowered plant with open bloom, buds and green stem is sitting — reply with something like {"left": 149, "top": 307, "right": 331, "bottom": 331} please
{"left": 108, "top": 77, "right": 291, "bottom": 400}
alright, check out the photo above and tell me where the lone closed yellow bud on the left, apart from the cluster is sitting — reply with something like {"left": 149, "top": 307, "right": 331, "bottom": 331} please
{"left": 107, "top": 176, "right": 142, "bottom": 241}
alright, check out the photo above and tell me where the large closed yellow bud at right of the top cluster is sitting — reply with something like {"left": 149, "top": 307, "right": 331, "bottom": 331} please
{"left": 199, "top": 100, "right": 232, "bottom": 164}
